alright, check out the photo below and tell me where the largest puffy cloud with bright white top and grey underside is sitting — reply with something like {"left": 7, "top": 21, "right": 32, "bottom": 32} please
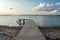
{"left": 32, "top": 3, "right": 55, "bottom": 11}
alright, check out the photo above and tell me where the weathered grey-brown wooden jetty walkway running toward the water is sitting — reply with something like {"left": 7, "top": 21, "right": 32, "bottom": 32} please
{"left": 16, "top": 19, "right": 46, "bottom": 40}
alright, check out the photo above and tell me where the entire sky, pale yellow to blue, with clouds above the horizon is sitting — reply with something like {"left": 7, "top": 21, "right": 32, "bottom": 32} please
{"left": 0, "top": 0, "right": 60, "bottom": 15}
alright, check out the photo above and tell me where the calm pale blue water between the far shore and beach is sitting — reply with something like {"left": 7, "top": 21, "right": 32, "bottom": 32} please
{"left": 0, "top": 15, "right": 60, "bottom": 27}
